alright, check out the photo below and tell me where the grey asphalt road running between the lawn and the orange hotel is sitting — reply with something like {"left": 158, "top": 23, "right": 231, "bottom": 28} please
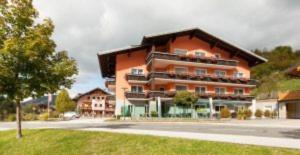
{"left": 0, "top": 121, "right": 300, "bottom": 139}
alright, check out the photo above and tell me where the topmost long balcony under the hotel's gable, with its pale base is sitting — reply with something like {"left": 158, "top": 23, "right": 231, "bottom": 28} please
{"left": 146, "top": 52, "right": 238, "bottom": 69}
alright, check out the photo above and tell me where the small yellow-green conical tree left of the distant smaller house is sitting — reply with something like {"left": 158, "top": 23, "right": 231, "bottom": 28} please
{"left": 55, "top": 89, "right": 75, "bottom": 113}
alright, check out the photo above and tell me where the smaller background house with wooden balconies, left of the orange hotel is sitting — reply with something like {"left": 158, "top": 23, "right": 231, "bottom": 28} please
{"left": 73, "top": 88, "right": 115, "bottom": 117}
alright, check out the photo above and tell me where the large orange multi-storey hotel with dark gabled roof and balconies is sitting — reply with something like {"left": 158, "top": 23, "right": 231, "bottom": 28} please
{"left": 98, "top": 28, "right": 267, "bottom": 117}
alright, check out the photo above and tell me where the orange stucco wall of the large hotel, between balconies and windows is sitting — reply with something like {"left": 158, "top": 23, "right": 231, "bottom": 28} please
{"left": 116, "top": 37, "right": 251, "bottom": 100}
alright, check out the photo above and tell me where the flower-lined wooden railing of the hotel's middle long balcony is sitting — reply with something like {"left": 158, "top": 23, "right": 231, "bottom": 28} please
{"left": 148, "top": 72, "right": 257, "bottom": 85}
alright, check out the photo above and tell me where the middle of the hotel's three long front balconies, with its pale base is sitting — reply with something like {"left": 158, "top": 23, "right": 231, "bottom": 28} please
{"left": 148, "top": 72, "right": 257, "bottom": 87}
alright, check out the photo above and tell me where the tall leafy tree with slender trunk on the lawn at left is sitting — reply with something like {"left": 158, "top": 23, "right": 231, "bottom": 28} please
{"left": 0, "top": 0, "right": 77, "bottom": 138}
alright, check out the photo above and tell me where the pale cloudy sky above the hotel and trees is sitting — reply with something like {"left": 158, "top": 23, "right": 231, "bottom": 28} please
{"left": 34, "top": 0, "right": 300, "bottom": 97}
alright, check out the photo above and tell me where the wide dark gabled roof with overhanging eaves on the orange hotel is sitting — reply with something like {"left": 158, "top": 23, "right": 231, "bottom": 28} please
{"left": 98, "top": 28, "right": 267, "bottom": 77}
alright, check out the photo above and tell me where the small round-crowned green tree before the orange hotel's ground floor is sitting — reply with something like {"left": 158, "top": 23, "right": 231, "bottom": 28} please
{"left": 173, "top": 91, "right": 198, "bottom": 117}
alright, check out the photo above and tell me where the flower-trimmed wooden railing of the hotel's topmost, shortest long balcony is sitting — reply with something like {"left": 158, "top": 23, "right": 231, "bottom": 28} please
{"left": 146, "top": 52, "right": 237, "bottom": 66}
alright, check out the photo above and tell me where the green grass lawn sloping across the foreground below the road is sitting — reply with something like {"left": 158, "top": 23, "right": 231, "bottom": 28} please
{"left": 0, "top": 129, "right": 300, "bottom": 155}
